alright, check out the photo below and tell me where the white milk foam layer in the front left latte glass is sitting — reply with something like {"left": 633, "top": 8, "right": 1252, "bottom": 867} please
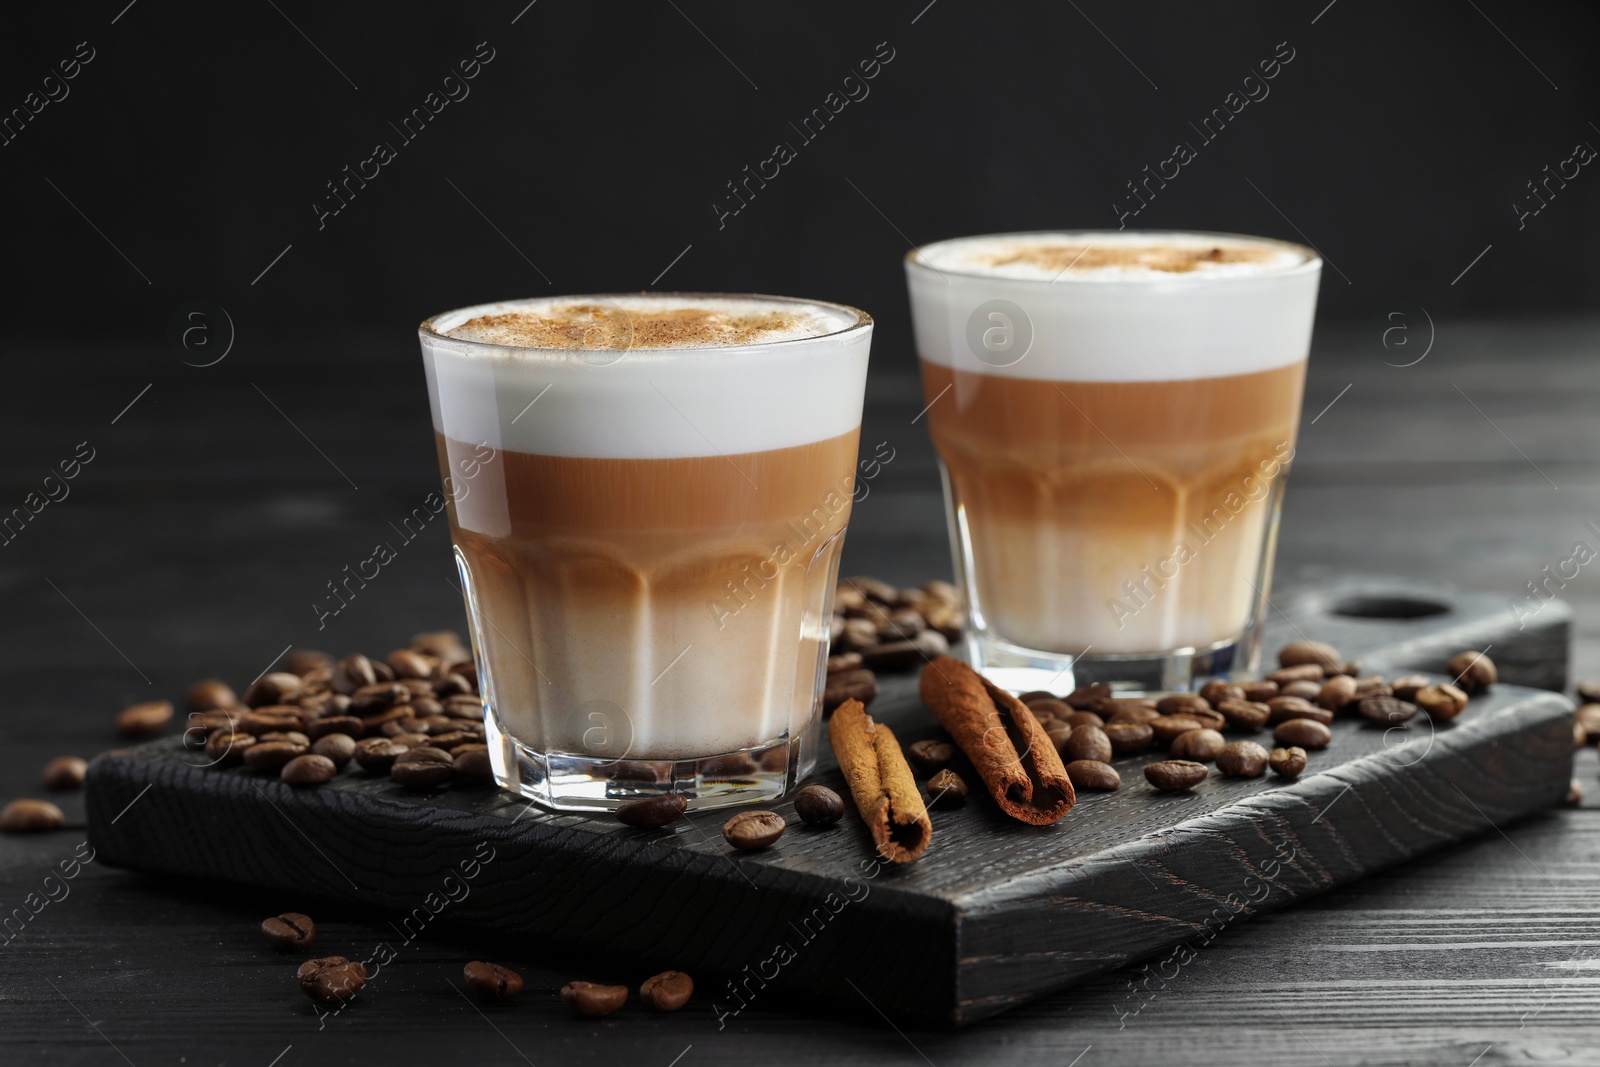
{"left": 419, "top": 294, "right": 872, "bottom": 459}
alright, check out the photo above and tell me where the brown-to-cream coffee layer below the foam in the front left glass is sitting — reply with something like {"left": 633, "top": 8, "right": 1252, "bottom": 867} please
{"left": 435, "top": 430, "right": 858, "bottom": 760}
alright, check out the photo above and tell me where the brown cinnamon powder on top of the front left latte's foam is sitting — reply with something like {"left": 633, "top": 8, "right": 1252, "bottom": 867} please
{"left": 450, "top": 304, "right": 832, "bottom": 349}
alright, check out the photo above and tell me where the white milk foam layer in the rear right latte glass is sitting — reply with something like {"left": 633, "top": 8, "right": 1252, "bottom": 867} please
{"left": 906, "top": 230, "right": 1322, "bottom": 382}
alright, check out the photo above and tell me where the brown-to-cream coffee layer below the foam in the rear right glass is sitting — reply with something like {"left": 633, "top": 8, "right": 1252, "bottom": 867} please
{"left": 922, "top": 360, "right": 1306, "bottom": 653}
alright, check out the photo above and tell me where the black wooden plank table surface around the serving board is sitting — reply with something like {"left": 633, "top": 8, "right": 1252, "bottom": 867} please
{"left": 0, "top": 322, "right": 1600, "bottom": 1067}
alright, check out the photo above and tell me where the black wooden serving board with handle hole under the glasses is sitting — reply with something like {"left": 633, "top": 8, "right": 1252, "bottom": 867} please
{"left": 88, "top": 579, "right": 1573, "bottom": 1024}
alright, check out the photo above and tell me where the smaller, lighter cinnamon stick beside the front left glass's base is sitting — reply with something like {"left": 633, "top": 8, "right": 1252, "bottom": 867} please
{"left": 827, "top": 701, "right": 933, "bottom": 864}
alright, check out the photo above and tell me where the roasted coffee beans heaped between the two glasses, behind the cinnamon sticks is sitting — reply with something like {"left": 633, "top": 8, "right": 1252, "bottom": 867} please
{"left": 822, "top": 577, "right": 962, "bottom": 712}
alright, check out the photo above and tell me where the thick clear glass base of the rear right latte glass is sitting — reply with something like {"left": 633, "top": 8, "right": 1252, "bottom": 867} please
{"left": 966, "top": 627, "right": 1261, "bottom": 696}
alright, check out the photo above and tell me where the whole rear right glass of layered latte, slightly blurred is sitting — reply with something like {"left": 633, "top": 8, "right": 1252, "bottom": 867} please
{"left": 906, "top": 232, "right": 1322, "bottom": 691}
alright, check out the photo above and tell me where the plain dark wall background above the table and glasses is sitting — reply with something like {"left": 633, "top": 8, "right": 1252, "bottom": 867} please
{"left": 0, "top": 0, "right": 1600, "bottom": 355}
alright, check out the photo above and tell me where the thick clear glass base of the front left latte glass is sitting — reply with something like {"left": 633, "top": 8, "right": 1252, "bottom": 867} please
{"left": 485, "top": 715, "right": 818, "bottom": 811}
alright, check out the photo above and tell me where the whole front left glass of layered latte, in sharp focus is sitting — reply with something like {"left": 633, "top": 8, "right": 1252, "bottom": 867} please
{"left": 419, "top": 294, "right": 872, "bottom": 811}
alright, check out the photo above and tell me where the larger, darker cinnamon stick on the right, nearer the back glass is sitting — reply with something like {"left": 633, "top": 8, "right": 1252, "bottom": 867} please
{"left": 918, "top": 656, "right": 1077, "bottom": 825}
